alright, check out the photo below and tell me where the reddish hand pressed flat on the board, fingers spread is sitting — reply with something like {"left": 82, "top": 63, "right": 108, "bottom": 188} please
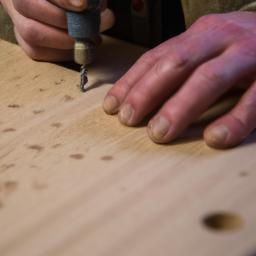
{"left": 103, "top": 12, "right": 256, "bottom": 148}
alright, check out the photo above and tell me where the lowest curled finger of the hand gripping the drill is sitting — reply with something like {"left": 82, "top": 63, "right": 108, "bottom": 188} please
{"left": 14, "top": 29, "right": 73, "bottom": 62}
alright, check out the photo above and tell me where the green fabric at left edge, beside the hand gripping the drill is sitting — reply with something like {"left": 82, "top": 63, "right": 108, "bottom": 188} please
{"left": 0, "top": 4, "right": 18, "bottom": 44}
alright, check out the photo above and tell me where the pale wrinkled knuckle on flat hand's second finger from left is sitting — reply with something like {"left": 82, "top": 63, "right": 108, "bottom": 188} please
{"left": 156, "top": 48, "right": 188, "bottom": 76}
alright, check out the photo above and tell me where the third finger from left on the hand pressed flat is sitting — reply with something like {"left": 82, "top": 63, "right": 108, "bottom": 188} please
{"left": 148, "top": 46, "right": 256, "bottom": 143}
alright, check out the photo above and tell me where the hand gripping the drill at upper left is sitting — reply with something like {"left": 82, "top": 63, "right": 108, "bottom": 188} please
{"left": 0, "top": 0, "right": 115, "bottom": 61}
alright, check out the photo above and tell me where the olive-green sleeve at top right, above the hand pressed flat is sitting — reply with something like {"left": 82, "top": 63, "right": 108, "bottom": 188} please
{"left": 181, "top": 0, "right": 256, "bottom": 28}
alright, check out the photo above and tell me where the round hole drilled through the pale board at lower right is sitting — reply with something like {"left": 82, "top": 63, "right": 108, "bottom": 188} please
{"left": 203, "top": 213, "right": 243, "bottom": 231}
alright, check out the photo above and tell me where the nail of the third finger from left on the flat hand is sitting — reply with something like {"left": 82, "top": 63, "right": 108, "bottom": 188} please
{"left": 148, "top": 116, "right": 171, "bottom": 140}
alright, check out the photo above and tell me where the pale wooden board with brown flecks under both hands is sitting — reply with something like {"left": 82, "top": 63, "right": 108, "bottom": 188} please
{"left": 0, "top": 37, "right": 256, "bottom": 256}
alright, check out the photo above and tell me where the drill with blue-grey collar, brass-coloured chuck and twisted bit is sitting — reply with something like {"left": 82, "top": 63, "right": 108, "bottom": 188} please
{"left": 66, "top": 0, "right": 100, "bottom": 92}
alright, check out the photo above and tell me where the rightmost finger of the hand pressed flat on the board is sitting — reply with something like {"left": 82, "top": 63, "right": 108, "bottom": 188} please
{"left": 204, "top": 83, "right": 256, "bottom": 148}
